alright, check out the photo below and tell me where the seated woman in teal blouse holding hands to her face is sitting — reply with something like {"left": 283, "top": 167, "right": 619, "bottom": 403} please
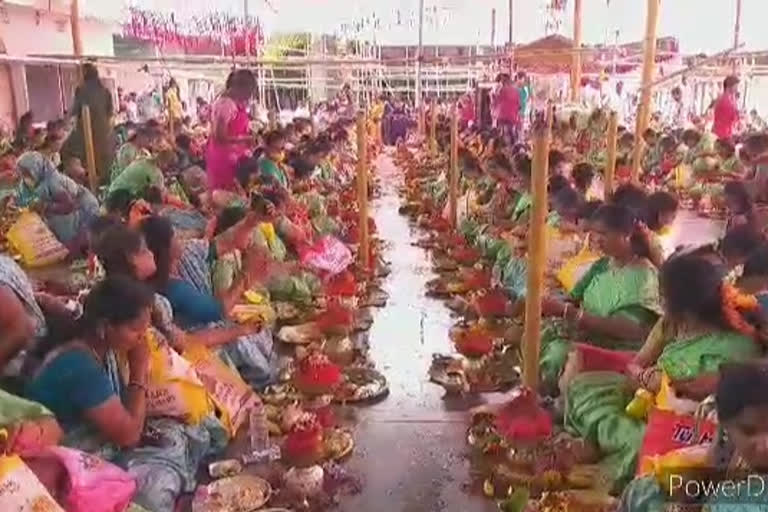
{"left": 27, "top": 276, "right": 226, "bottom": 512}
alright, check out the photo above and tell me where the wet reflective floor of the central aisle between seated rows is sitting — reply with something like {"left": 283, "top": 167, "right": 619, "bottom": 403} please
{"left": 341, "top": 156, "right": 497, "bottom": 512}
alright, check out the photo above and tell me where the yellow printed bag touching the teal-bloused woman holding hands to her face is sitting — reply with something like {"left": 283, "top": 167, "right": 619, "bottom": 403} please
{"left": 146, "top": 329, "right": 213, "bottom": 425}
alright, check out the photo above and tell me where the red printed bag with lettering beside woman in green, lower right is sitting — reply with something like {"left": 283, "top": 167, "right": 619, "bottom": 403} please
{"left": 637, "top": 409, "right": 717, "bottom": 475}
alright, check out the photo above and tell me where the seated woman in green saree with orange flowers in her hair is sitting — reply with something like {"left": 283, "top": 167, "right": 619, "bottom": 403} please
{"left": 561, "top": 253, "right": 759, "bottom": 496}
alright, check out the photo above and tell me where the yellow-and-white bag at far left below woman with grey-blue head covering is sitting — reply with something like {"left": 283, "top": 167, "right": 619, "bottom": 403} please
{"left": 6, "top": 211, "right": 69, "bottom": 267}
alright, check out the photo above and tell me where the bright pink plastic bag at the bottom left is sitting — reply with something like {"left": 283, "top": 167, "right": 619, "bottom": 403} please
{"left": 36, "top": 446, "right": 136, "bottom": 512}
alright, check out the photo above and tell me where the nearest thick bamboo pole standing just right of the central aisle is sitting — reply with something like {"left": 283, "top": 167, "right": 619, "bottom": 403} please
{"left": 523, "top": 107, "right": 553, "bottom": 390}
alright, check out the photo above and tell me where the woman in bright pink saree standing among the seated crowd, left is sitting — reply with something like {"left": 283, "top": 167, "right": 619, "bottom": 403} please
{"left": 205, "top": 69, "right": 256, "bottom": 192}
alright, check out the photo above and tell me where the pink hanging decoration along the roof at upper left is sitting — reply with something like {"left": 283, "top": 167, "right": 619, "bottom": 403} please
{"left": 123, "top": 7, "right": 264, "bottom": 56}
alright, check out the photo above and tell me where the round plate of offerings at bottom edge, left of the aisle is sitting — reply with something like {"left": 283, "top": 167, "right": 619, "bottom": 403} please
{"left": 192, "top": 475, "right": 272, "bottom": 512}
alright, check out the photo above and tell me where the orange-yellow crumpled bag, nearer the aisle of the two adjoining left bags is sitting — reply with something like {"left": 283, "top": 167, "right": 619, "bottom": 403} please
{"left": 184, "top": 345, "right": 261, "bottom": 437}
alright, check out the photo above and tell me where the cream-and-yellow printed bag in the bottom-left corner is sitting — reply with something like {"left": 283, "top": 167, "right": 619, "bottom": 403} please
{"left": 0, "top": 455, "right": 64, "bottom": 512}
